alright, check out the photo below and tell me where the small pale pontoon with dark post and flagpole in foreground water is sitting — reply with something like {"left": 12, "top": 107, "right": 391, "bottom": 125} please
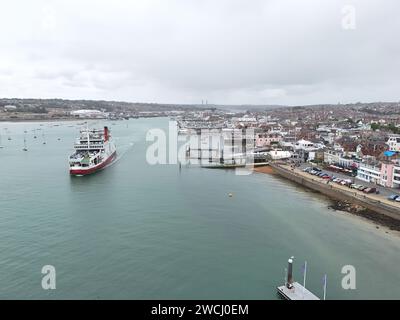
{"left": 277, "top": 257, "right": 320, "bottom": 300}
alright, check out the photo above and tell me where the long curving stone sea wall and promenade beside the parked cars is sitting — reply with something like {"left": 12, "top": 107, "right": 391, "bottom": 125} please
{"left": 270, "top": 163, "right": 400, "bottom": 221}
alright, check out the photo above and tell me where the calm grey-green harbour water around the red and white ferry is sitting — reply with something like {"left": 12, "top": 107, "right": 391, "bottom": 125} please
{"left": 0, "top": 118, "right": 400, "bottom": 299}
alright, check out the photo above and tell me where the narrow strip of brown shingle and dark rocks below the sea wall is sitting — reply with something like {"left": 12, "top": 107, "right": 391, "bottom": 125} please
{"left": 254, "top": 166, "right": 400, "bottom": 236}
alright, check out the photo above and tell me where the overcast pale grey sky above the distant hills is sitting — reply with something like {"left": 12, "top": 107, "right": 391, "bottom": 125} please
{"left": 0, "top": 0, "right": 400, "bottom": 105}
